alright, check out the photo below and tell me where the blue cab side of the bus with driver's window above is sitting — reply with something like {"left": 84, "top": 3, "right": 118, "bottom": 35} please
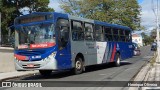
{"left": 56, "top": 19, "right": 71, "bottom": 69}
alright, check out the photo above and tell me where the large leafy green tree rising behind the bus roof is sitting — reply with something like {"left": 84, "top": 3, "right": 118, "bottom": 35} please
{"left": 60, "top": 0, "right": 140, "bottom": 30}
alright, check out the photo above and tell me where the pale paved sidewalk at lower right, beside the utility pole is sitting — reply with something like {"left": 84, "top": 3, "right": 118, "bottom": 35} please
{"left": 129, "top": 54, "right": 160, "bottom": 90}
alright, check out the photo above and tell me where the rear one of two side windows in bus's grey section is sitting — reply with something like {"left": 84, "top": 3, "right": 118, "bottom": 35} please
{"left": 85, "top": 23, "right": 94, "bottom": 40}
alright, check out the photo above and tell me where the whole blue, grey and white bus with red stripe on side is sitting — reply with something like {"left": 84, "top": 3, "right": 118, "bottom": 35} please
{"left": 14, "top": 12, "right": 133, "bottom": 75}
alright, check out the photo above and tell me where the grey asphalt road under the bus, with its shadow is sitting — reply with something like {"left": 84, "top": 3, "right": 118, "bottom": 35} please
{"left": 0, "top": 46, "right": 153, "bottom": 90}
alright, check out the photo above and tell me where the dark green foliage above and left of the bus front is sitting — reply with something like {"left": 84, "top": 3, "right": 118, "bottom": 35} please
{"left": 0, "top": 0, "right": 54, "bottom": 34}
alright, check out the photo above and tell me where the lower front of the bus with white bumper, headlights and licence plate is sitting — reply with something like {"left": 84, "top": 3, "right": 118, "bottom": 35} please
{"left": 14, "top": 46, "right": 58, "bottom": 71}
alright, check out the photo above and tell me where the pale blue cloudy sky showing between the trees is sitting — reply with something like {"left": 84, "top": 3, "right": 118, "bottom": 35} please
{"left": 49, "top": 0, "right": 157, "bottom": 33}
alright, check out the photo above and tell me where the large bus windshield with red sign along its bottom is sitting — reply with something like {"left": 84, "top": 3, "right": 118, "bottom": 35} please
{"left": 16, "top": 24, "right": 55, "bottom": 49}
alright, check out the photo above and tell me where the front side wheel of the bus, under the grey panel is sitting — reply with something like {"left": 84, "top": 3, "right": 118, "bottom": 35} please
{"left": 74, "top": 57, "right": 84, "bottom": 75}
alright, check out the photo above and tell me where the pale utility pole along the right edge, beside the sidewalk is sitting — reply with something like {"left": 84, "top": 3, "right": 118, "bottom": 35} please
{"left": 156, "top": 0, "right": 160, "bottom": 63}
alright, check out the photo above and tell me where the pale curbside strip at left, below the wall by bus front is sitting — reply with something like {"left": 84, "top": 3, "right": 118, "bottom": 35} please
{"left": 0, "top": 71, "right": 39, "bottom": 81}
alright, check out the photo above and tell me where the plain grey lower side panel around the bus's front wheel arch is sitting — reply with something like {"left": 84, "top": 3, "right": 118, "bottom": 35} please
{"left": 71, "top": 41, "right": 97, "bottom": 67}
